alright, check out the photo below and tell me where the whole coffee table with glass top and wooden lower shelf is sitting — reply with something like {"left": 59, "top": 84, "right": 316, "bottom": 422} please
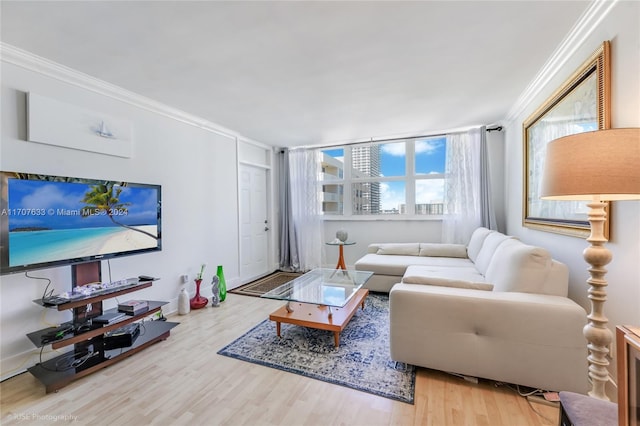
{"left": 261, "top": 269, "right": 373, "bottom": 347}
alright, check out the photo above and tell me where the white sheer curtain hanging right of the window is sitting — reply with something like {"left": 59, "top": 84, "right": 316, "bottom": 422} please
{"left": 442, "top": 129, "right": 482, "bottom": 244}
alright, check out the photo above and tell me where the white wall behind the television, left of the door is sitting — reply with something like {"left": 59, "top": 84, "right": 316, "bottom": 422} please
{"left": 0, "top": 62, "right": 238, "bottom": 378}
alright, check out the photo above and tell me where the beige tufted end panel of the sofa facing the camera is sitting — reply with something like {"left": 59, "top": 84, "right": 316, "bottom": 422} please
{"left": 389, "top": 283, "right": 588, "bottom": 392}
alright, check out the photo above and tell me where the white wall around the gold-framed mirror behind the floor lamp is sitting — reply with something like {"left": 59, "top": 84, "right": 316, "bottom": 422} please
{"left": 505, "top": 2, "right": 640, "bottom": 392}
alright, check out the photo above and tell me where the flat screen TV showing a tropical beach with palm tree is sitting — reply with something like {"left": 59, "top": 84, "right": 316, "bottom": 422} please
{"left": 0, "top": 172, "right": 162, "bottom": 275}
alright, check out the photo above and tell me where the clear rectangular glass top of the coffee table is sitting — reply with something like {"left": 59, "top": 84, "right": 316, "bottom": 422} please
{"left": 260, "top": 268, "right": 373, "bottom": 308}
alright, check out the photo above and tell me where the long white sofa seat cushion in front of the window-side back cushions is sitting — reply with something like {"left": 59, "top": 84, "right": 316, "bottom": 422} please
{"left": 355, "top": 253, "right": 473, "bottom": 276}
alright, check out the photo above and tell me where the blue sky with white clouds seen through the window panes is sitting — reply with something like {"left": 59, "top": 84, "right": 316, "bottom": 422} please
{"left": 324, "top": 137, "right": 446, "bottom": 210}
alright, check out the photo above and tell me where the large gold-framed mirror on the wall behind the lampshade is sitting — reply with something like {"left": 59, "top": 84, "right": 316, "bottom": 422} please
{"left": 522, "top": 41, "right": 611, "bottom": 238}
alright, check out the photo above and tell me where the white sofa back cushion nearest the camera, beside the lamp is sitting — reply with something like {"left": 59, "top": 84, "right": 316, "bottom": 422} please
{"left": 485, "top": 239, "right": 552, "bottom": 293}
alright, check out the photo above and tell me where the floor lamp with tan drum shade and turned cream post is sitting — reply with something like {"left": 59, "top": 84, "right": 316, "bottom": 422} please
{"left": 541, "top": 128, "right": 640, "bottom": 400}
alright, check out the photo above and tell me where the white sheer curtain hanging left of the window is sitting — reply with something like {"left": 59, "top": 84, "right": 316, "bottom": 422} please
{"left": 289, "top": 149, "right": 323, "bottom": 271}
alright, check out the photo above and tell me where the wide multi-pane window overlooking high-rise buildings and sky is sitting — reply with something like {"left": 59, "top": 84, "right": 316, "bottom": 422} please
{"left": 321, "top": 136, "right": 446, "bottom": 216}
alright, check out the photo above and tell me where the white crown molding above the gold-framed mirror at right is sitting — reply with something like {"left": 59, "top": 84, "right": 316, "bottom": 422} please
{"left": 505, "top": 0, "right": 618, "bottom": 122}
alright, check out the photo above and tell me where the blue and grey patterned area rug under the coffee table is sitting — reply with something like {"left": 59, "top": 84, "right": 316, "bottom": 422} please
{"left": 218, "top": 293, "right": 415, "bottom": 404}
